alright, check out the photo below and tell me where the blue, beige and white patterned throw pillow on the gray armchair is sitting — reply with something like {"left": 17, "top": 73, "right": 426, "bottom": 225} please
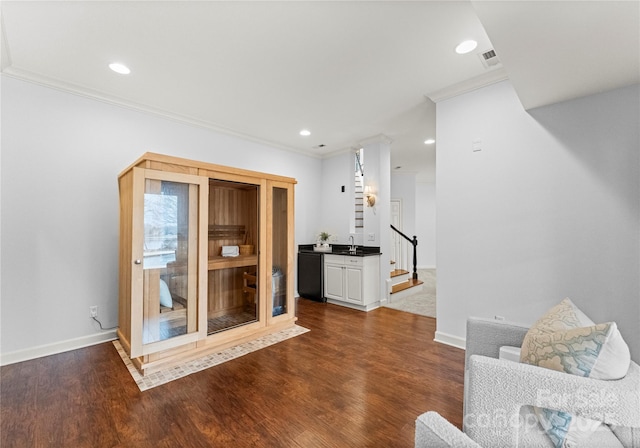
{"left": 520, "top": 298, "right": 631, "bottom": 448}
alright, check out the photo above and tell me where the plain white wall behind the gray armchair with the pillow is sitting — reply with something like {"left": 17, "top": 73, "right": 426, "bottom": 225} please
{"left": 436, "top": 81, "right": 640, "bottom": 361}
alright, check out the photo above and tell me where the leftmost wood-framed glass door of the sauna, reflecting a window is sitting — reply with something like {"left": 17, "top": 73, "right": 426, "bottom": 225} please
{"left": 131, "top": 168, "right": 208, "bottom": 357}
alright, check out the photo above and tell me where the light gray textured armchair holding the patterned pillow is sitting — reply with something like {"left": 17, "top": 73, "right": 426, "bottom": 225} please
{"left": 415, "top": 318, "right": 640, "bottom": 448}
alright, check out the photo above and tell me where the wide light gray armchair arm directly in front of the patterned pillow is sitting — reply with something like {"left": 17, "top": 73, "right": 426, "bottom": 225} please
{"left": 464, "top": 355, "right": 640, "bottom": 446}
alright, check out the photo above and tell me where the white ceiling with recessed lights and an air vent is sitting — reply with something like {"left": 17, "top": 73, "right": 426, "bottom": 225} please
{"left": 1, "top": 1, "right": 640, "bottom": 181}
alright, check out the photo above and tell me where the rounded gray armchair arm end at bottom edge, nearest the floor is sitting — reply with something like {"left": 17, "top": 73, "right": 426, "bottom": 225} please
{"left": 415, "top": 412, "right": 481, "bottom": 448}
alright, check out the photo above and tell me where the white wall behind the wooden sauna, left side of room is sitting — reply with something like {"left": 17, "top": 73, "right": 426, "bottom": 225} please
{"left": 0, "top": 76, "right": 321, "bottom": 362}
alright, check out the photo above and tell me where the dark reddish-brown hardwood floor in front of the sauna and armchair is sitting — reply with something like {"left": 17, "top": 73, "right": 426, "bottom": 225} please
{"left": 0, "top": 299, "right": 464, "bottom": 448}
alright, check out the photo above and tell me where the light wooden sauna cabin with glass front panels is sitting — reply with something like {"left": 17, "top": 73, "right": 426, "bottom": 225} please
{"left": 118, "top": 153, "right": 296, "bottom": 374}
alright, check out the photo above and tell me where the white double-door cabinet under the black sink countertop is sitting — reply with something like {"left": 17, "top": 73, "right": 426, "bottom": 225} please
{"left": 324, "top": 255, "right": 380, "bottom": 311}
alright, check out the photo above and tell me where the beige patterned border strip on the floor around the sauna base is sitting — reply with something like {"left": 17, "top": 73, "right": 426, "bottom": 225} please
{"left": 113, "top": 325, "right": 309, "bottom": 391}
